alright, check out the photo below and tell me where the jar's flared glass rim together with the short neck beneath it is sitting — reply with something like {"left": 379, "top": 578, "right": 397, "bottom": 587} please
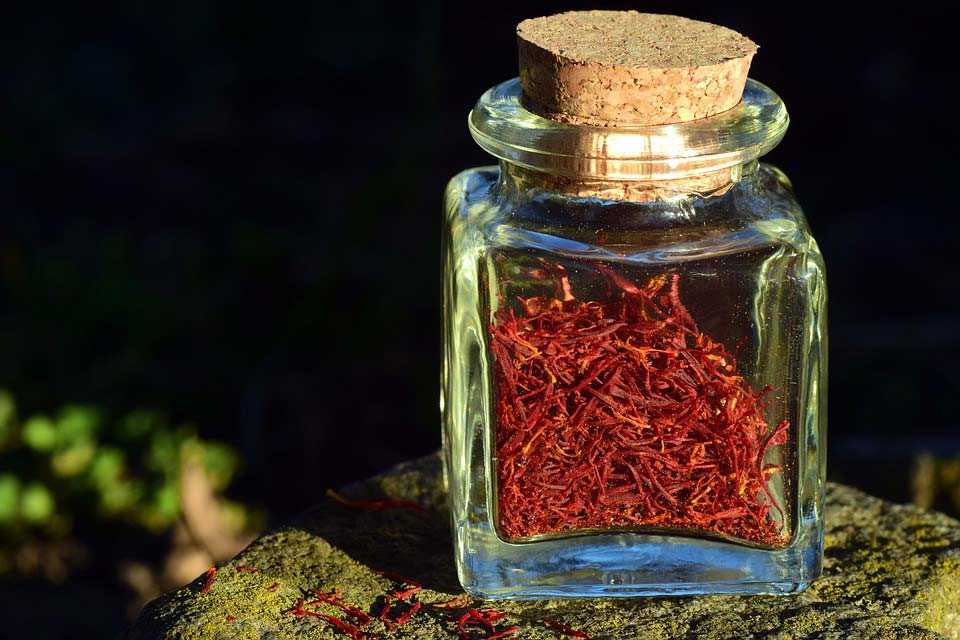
{"left": 469, "top": 78, "right": 790, "bottom": 202}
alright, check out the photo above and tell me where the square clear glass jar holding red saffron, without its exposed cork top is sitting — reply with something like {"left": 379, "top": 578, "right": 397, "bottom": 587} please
{"left": 441, "top": 79, "right": 827, "bottom": 599}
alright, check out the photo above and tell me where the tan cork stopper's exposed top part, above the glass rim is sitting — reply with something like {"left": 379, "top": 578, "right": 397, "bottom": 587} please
{"left": 517, "top": 11, "right": 757, "bottom": 127}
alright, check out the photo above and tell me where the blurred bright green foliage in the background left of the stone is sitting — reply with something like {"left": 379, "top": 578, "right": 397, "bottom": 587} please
{"left": 0, "top": 389, "right": 250, "bottom": 552}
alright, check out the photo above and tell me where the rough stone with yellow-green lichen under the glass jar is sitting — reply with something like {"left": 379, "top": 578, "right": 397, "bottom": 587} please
{"left": 127, "top": 456, "right": 960, "bottom": 640}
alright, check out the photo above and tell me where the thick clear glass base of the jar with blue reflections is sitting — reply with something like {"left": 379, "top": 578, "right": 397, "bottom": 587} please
{"left": 458, "top": 526, "right": 822, "bottom": 600}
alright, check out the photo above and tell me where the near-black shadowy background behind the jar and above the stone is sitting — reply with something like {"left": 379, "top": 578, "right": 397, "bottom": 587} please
{"left": 0, "top": 2, "right": 960, "bottom": 637}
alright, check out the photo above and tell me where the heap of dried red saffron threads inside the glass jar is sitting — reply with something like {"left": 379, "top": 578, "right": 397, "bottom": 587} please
{"left": 490, "top": 267, "right": 790, "bottom": 546}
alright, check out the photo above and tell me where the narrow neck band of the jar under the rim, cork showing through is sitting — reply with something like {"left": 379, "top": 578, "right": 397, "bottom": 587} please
{"left": 499, "top": 160, "right": 758, "bottom": 202}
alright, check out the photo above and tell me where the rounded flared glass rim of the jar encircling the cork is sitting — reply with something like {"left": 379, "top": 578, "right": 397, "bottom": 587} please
{"left": 468, "top": 78, "right": 790, "bottom": 181}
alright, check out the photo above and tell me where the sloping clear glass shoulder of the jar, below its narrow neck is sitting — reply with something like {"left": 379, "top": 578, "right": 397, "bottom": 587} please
{"left": 445, "top": 163, "right": 823, "bottom": 271}
